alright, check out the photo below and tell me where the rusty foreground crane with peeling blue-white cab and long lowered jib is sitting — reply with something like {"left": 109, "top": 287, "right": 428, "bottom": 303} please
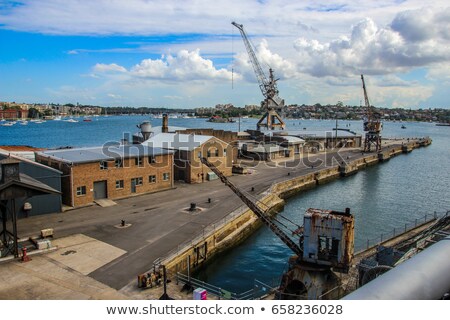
{"left": 201, "top": 158, "right": 355, "bottom": 299}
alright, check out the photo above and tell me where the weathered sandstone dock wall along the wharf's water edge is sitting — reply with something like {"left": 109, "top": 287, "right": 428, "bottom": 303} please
{"left": 155, "top": 138, "right": 431, "bottom": 272}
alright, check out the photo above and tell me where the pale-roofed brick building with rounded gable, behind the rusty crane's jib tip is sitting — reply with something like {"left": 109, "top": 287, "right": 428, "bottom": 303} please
{"left": 142, "top": 133, "right": 233, "bottom": 183}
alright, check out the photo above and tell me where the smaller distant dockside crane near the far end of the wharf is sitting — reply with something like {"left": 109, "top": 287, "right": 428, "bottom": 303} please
{"left": 361, "top": 75, "right": 382, "bottom": 152}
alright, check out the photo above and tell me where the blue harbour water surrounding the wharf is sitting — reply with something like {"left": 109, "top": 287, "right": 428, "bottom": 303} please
{"left": 0, "top": 116, "right": 450, "bottom": 292}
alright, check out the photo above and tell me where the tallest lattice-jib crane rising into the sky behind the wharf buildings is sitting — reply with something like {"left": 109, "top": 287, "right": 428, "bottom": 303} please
{"left": 231, "top": 22, "right": 286, "bottom": 130}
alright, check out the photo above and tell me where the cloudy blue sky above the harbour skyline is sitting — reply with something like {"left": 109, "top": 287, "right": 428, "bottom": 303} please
{"left": 0, "top": 0, "right": 450, "bottom": 108}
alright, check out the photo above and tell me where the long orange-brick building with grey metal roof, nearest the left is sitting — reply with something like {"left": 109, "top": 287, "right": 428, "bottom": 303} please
{"left": 36, "top": 145, "right": 173, "bottom": 207}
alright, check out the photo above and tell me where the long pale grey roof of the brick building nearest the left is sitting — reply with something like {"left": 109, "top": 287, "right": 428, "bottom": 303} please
{"left": 37, "top": 144, "right": 173, "bottom": 163}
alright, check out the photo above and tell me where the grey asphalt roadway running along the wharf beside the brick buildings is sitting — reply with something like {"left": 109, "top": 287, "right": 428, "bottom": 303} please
{"left": 14, "top": 146, "right": 398, "bottom": 290}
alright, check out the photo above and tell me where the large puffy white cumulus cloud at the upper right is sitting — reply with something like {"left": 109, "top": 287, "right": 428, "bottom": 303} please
{"left": 294, "top": 8, "right": 450, "bottom": 77}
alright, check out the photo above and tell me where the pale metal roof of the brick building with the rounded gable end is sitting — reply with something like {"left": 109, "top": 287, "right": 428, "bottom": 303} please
{"left": 142, "top": 133, "right": 214, "bottom": 151}
